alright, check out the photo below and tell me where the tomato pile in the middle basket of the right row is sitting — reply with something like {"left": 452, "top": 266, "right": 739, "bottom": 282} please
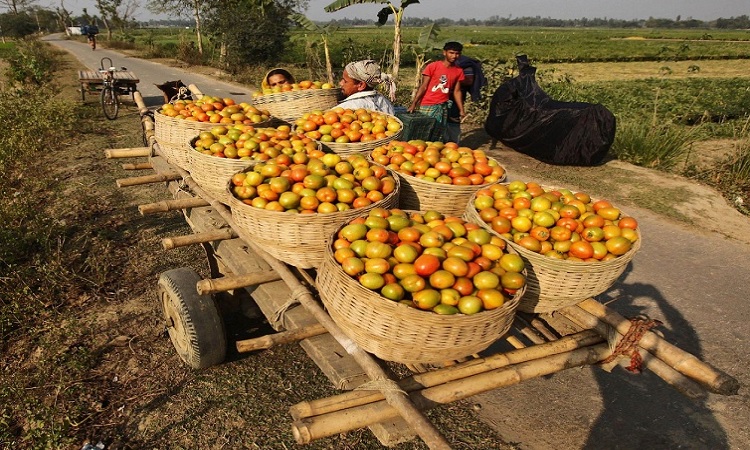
{"left": 370, "top": 140, "right": 505, "bottom": 185}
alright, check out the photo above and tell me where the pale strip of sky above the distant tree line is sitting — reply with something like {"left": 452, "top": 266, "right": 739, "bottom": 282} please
{"left": 64, "top": 0, "right": 750, "bottom": 21}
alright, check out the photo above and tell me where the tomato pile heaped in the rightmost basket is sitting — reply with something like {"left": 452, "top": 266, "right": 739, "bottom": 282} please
{"left": 472, "top": 181, "right": 639, "bottom": 262}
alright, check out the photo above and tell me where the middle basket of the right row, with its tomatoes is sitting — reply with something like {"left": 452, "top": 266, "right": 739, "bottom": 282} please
{"left": 369, "top": 140, "right": 506, "bottom": 216}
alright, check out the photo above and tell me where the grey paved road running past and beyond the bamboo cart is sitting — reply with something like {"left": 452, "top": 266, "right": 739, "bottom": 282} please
{"left": 52, "top": 34, "right": 750, "bottom": 449}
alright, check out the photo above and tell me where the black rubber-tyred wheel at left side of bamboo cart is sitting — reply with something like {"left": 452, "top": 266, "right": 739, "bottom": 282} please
{"left": 159, "top": 267, "right": 227, "bottom": 369}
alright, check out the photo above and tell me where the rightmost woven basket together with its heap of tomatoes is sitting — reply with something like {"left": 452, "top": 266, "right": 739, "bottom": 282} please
{"left": 465, "top": 181, "right": 641, "bottom": 313}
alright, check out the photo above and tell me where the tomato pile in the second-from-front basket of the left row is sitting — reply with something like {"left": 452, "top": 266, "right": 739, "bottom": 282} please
{"left": 231, "top": 150, "right": 398, "bottom": 214}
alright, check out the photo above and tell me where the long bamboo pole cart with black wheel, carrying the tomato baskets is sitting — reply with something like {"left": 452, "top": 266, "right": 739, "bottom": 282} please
{"left": 106, "top": 86, "right": 739, "bottom": 449}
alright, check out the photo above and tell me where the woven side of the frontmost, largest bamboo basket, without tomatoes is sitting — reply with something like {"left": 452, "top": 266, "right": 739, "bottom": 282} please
{"left": 316, "top": 213, "right": 523, "bottom": 364}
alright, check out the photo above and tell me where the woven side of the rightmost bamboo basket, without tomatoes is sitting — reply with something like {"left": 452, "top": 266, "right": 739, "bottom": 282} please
{"left": 464, "top": 188, "right": 641, "bottom": 313}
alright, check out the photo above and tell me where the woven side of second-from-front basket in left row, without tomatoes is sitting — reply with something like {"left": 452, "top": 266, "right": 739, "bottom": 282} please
{"left": 225, "top": 169, "right": 400, "bottom": 269}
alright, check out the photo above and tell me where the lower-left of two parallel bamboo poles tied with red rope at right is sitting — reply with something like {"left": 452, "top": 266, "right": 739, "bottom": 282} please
{"left": 559, "top": 306, "right": 706, "bottom": 399}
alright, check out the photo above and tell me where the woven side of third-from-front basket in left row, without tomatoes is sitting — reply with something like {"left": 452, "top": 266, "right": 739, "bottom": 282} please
{"left": 187, "top": 136, "right": 259, "bottom": 204}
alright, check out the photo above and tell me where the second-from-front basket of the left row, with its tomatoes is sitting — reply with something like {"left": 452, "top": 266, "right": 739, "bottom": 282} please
{"left": 227, "top": 150, "right": 399, "bottom": 269}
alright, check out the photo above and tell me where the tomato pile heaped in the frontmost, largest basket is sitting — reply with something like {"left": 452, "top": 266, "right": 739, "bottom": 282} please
{"left": 332, "top": 208, "right": 526, "bottom": 314}
